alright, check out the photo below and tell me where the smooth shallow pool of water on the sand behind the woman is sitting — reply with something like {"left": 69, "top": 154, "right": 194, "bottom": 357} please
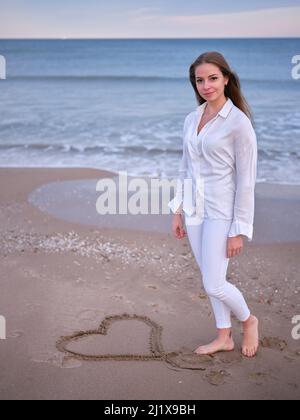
{"left": 14, "top": 168, "right": 300, "bottom": 244}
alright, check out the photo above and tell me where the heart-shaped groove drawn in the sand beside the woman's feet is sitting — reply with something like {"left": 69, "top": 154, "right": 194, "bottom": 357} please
{"left": 56, "top": 314, "right": 214, "bottom": 370}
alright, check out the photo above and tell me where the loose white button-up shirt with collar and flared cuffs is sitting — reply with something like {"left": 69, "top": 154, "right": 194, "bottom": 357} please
{"left": 168, "top": 98, "right": 257, "bottom": 241}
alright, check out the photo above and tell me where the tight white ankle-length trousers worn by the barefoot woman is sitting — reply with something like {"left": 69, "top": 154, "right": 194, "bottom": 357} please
{"left": 185, "top": 216, "right": 251, "bottom": 328}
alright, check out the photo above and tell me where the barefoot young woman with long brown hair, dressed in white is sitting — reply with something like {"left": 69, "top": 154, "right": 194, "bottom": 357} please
{"left": 168, "top": 52, "right": 259, "bottom": 357}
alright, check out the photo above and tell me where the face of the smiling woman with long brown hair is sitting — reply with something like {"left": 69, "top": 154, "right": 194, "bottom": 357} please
{"left": 195, "top": 63, "right": 228, "bottom": 102}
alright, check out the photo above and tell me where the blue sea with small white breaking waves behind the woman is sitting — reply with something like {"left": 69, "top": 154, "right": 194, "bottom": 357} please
{"left": 0, "top": 38, "right": 300, "bottom": 185}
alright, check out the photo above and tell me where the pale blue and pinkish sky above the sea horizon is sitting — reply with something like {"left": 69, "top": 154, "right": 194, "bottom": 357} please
{"left": 0, "top": 0, "right": 300, "bottom": 38}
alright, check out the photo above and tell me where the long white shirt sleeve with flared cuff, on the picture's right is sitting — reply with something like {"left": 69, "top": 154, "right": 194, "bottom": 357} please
{"left": 228, "top": 117, "right": 257, "bottom": 241}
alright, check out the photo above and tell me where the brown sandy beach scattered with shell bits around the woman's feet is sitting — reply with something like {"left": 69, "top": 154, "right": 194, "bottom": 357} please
{"left": 0, "top": 168, "right": 300, "bottom": 400}
